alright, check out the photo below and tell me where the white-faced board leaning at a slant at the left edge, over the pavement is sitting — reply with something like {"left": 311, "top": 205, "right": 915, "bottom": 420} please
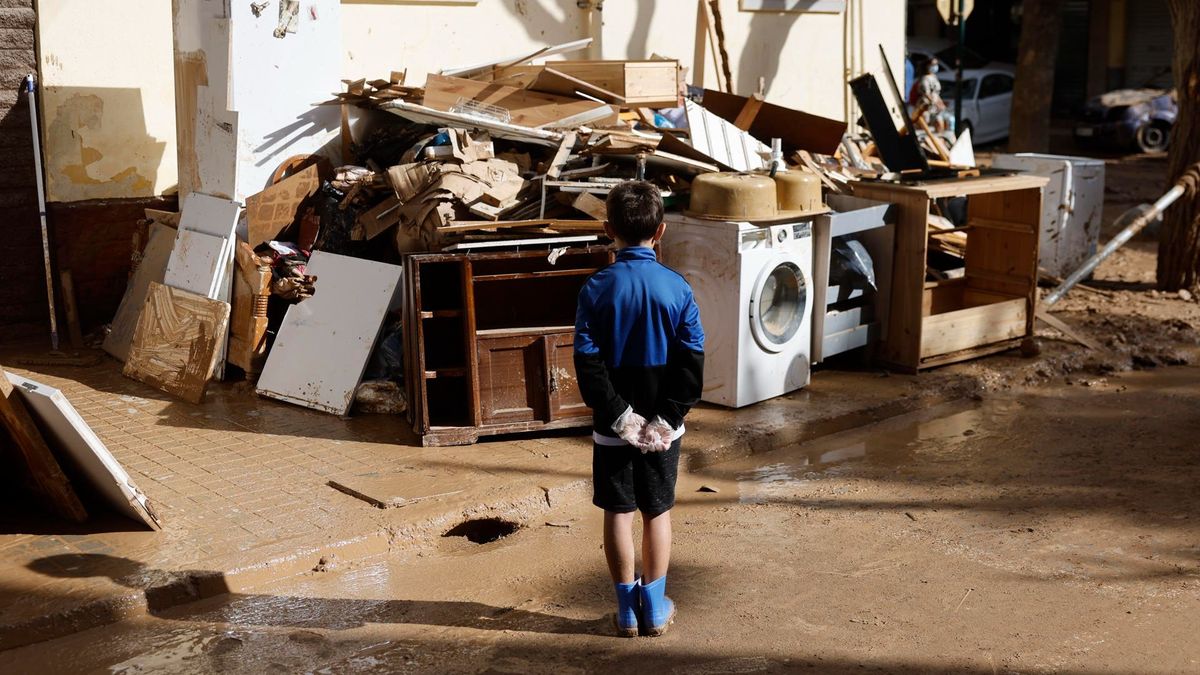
{"left": 6, "top": 372, "right": 162, "bottom": 530}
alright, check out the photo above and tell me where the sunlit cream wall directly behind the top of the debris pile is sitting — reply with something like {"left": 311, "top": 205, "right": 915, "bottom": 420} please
{"left": 342, "top": 0, "right": 905, "bottom": 119}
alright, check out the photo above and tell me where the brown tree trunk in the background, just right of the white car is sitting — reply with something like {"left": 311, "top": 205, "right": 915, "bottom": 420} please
{"left": 1008, "top": 0, "right": 1062, "bottom": 153}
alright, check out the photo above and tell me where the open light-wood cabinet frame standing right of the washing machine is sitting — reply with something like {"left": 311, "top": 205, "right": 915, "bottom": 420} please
{"left": 853, "top": 175, "right": 1046, "bottom": 372}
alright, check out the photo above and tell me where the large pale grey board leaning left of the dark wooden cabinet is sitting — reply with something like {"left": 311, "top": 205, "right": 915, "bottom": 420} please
{"left": 258, "top": 251, "right": 401, "bottom": 414}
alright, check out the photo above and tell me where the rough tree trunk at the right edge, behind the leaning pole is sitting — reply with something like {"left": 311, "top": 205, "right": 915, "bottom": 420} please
{"left": 1158, "top": 0, "right": 1200, "bottom": 291}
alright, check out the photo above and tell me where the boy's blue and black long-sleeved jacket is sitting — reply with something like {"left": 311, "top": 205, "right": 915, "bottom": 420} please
{"left": 575, "top": 246, "right": 704, "bottom": 443}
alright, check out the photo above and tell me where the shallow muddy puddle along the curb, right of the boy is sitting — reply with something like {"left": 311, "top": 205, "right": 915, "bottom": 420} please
{"left": 736, "top": 404, "right": 997, "bottom": 503}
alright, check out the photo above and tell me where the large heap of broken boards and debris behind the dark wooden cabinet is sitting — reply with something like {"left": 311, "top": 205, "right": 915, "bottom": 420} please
{"left": 104, "top": 40, "right": 846, "bottom": 414}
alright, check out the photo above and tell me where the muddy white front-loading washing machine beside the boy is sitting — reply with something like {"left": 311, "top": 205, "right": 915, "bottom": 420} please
{"left": 662, "top": 214, "right": 814, "bottom": 407}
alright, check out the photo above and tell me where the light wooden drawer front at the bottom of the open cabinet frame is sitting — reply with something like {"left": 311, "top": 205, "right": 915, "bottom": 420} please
{"left": 920, "top": 298, "right": 1026, "bottom": 359}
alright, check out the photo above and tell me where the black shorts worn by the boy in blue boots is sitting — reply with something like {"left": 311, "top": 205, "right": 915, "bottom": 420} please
{"left": 592, "top": 440, "right": 679, "bottom": 518}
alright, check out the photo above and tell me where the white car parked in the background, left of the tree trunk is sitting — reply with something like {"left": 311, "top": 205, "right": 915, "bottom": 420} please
{"left": 938, "top": 64, "right": 1014, "bottom": 143}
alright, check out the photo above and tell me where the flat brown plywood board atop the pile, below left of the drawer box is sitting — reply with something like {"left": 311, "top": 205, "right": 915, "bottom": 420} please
{"left": 422, "top": 74, "right": 617, "bottom": 129}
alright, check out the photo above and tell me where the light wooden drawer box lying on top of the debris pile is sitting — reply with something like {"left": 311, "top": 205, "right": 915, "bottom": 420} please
{"left": 494, "top": 60, "right": 679, "bottom": 108}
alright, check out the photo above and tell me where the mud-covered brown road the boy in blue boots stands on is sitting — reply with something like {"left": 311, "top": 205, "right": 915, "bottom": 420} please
{"left": 0, "top": 368, "right": 1200, "bottom": 673}
